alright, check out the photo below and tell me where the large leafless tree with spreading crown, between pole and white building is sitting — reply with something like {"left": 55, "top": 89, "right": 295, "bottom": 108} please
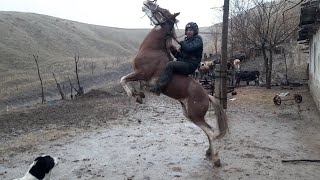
{"left": 231, "top": 0, "right": 299, "bottom": 89}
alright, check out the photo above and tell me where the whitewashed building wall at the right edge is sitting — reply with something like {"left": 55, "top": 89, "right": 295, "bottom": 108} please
{"left": 309, "top": 28, "right": 320, "bottom": 110}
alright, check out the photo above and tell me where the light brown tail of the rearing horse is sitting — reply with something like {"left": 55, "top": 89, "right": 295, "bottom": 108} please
{"left": 209, "top": 95, "right": 229, "bottom": 139}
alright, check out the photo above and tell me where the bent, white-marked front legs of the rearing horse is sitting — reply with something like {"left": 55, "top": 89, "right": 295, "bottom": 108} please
{"left": 120, "top": 72, "right": 145, "bottom": 104}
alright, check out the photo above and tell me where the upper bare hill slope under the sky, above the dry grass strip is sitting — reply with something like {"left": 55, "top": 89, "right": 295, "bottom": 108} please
{"left": 0, "top": 12, "right": 149, "bottom": 72}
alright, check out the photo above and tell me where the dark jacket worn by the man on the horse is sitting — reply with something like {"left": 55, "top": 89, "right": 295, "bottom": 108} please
{"left": 171, "top": 35, "right": 203, "bottom": 68}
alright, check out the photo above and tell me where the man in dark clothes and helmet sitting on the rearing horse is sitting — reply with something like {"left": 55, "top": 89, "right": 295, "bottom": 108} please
{"left": 150, "top": 22, "right": 203, "bottom": 94}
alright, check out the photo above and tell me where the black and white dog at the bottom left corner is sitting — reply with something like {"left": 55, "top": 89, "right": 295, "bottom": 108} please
{"left": 14, "top": 155, "right": 59, "bottom": 180}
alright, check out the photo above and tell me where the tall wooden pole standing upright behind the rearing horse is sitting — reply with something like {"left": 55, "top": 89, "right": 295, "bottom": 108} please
{"left": 219, "top": 0, "right": 229, "bottom": 109}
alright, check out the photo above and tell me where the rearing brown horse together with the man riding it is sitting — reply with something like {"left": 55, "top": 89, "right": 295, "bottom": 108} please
{"left": 120, "top": 0, "right": 228, "bottom": 166}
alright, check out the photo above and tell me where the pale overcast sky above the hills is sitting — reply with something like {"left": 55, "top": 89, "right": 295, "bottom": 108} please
{"left": 0, "top": 0, "right": 223, "bottom": 28}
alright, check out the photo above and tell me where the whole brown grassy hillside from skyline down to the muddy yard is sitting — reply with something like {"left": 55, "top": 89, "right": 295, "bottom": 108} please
{"left": 0, "top": 12, "right": 215, "bottom": 111}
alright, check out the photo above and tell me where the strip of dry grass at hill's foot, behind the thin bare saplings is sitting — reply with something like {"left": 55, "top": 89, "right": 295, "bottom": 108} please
{"left": 0, "top": 56, "right": 133, "bottom": 111}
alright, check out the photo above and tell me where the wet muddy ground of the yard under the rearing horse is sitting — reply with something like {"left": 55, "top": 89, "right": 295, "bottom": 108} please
{"left": 0, "top": 84, "right": 320, "bottom": 180}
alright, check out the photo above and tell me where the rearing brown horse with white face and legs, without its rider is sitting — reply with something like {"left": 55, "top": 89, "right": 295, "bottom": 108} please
{"left": 120, "top": 0, "right": 228, "bottom": 166}
